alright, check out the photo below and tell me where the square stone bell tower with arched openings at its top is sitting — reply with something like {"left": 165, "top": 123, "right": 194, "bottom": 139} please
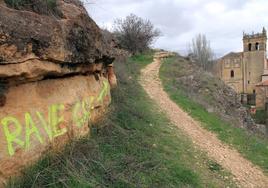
{"left": 243, "top": 28, "right": 267, "bottom": 94}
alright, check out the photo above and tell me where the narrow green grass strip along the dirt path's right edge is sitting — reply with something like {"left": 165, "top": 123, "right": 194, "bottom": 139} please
{"left": 160, "top": 58, "right": 268, "bottom": 174}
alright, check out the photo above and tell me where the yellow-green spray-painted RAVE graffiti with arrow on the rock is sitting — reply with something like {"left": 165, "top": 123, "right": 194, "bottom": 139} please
{"left": 1, "top": 81, "right": 109, "bottom": 156}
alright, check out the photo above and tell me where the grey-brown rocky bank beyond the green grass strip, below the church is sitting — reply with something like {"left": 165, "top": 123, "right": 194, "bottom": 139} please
{"left": 160, "top": 56, "right": 261, "bottom": 136}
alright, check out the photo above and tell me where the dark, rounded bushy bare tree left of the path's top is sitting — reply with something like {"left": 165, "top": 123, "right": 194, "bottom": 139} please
{"left": 114, "top": 14, "right": 160, "bottom": 54}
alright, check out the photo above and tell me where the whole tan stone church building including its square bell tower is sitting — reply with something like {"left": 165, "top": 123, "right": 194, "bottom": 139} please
{"left": 218, "top": 28, "right": 268, "bottom": 107}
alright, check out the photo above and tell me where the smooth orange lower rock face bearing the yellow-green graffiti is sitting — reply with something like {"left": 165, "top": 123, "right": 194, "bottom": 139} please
{"left": 0, "top": 76, "right": 110, "bottom": 185}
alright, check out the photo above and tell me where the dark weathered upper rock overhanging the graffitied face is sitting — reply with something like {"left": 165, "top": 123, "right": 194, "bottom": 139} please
{"left": 0, "top": 1, "right": 113, "bottom": 82}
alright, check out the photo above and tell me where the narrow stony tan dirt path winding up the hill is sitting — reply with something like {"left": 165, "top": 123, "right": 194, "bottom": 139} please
{"left": 140, "top": 55, "right": 268, "bottom": 188}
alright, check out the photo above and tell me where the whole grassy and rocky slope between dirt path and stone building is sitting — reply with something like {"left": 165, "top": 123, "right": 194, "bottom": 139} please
{"left": 160, "top": 57, "right": 268, "bottom": 174}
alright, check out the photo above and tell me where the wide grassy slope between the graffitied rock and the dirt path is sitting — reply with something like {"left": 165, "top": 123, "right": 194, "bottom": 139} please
{"left": 8, "top": 55, "right": 235, "bottom": 188}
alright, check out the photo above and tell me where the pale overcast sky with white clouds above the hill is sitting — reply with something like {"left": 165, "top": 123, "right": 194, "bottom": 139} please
{"left": 84, "top": 0, "right": 268, "bottom": 56}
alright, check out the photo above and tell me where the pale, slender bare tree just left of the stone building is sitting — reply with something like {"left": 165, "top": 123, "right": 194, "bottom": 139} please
{"left": 190, "top": 34, "right": 214, "bottom": 70}
